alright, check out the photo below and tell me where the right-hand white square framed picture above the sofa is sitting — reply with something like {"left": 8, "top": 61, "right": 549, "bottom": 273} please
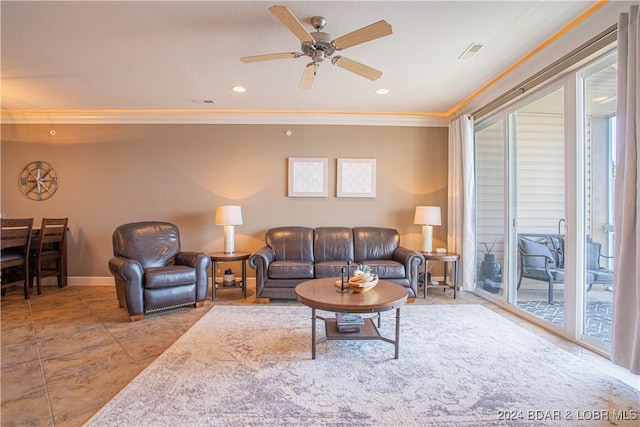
{"left": 336, "top": 159, "right": 376, "bottom": 197}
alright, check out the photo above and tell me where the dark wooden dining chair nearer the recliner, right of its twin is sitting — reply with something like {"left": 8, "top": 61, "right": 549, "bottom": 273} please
{"left": 32, "top": 218, "right": 69, "bottom": 295}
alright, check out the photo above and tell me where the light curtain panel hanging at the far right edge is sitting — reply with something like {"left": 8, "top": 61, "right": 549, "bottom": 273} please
{"left": 611, "top": 6, "right": 640, "bottom": 374}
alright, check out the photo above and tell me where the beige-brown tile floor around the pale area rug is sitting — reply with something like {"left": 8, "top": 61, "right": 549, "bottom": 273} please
{"left": 0, "top": 286, "right": 636, "bottom": 426}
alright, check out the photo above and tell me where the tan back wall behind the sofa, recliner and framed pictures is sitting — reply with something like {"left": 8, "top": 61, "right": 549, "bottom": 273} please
{"left": 0, "top": 125, "right": 447, "bottom": 277}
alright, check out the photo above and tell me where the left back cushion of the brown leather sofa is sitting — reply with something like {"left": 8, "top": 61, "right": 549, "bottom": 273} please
{"left": 265, "top": 227, "right": 313, "bottom": 264}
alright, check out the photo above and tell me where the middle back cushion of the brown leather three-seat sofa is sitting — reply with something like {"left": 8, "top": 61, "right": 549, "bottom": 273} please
{"left": 313, "top": 227, "right": 353, "bottom": 264}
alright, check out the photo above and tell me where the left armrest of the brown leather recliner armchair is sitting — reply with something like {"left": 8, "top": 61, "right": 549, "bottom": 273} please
{"left": 109, "top": 256, "right": 144, "bottom": 315}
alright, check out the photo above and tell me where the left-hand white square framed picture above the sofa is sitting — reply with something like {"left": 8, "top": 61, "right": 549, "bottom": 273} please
{"left": 287, "top": 157, "right": 329, "bottom": 197}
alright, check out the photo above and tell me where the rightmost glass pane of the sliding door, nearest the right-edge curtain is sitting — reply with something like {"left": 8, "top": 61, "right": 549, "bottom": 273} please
{"left": 580, "top": 58, "right": 616, "bottom": 346}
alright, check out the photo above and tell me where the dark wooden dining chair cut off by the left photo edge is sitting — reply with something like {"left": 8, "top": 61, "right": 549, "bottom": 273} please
{"left": 0, "top": 218, "right": 33, "bottom": 299}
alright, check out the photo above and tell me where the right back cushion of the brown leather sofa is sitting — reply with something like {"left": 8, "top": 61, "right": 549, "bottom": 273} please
{"left": 353, "top": 227, "right": 400, "bottom": 264}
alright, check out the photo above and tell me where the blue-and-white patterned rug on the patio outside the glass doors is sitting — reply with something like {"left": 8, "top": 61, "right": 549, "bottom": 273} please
{"left": 518, "top": 301, "right": 613, "bottom": 344}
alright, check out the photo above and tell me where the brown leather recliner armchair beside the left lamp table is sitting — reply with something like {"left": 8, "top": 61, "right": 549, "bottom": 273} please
{"left": 109, "top": 221, "right": 211, "bottom": 321}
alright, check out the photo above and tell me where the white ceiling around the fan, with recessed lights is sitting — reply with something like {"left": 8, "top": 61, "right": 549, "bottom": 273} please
{"left": 1, "top": 1, "right": 608, "bottom": 123}
